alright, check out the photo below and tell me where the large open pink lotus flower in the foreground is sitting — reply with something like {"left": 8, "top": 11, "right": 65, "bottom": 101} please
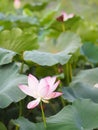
{"left": 19, "top": 74, "right": 62, "bottom": 109}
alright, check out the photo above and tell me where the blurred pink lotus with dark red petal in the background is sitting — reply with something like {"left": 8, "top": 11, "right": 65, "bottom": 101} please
{"left": 57, "top": 11, "right": 74, "bottom": 22}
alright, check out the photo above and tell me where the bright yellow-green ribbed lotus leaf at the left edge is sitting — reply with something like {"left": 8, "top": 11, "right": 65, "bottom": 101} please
{"left": 0, "top": 28, "right": 38, "bottom": 52}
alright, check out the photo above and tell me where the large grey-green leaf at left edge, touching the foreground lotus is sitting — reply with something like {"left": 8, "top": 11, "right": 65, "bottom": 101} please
{"left": 0, "top": 64, "right": 27, "bottom": 108}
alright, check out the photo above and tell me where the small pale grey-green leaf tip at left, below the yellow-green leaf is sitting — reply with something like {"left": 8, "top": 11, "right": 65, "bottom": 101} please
{"left": 0, "top": 48, "right": 16, "bottom": 65}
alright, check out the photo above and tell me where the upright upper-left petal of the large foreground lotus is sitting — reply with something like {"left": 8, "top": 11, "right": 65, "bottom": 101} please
{"left": 28, "top": 74, "right": 39, "bottom": 90}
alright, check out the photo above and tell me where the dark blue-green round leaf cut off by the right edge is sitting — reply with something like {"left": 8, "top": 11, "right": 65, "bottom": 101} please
{"left": 81, "top": 43, "right": 98, "bottom": 63}
